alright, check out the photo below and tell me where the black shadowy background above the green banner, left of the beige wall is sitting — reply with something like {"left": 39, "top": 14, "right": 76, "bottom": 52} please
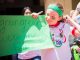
{"left": 0, "top": 0, "right": 44, "bottom": 15}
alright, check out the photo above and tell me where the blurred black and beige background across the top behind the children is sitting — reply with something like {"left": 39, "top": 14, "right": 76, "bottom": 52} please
{"left": 0, "top": 0, "right": 80, "bottom": 15}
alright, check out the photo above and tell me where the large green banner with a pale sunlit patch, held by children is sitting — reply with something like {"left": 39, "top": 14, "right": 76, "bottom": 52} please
{"left": 0, "top": 15, "right": 53, "bottom": 56}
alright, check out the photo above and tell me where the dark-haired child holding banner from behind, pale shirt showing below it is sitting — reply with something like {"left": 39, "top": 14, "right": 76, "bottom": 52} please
{"left": 18, "top": 7, "right": 41, "bottom": 60}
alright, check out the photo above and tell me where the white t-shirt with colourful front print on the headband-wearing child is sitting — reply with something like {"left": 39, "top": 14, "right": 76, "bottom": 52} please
{"left": 50, "top": 23, "right": 71, "bottom": 60}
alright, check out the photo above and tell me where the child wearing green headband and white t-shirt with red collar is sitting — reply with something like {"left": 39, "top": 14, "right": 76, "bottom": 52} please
{"left": 33, "top": 3, "right": 80, "bottom": 60}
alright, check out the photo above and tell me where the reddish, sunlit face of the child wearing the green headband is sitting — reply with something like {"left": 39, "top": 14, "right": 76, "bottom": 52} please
{"left": 46, "top": 9, "right": 61, "bottom": 25}
